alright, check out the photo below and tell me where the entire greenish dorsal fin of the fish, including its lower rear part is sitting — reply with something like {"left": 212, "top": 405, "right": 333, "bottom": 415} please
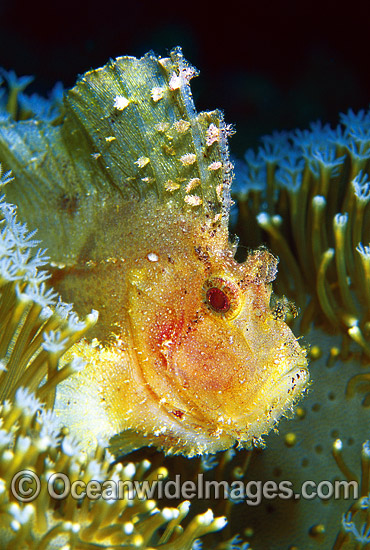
{"left": 0, "top": 48, "right": 231, "bottom": 264}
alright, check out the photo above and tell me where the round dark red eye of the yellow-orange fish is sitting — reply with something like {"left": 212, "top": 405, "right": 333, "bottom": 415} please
{"left": 203, "top": 277, "right": 242, "bottom": 318}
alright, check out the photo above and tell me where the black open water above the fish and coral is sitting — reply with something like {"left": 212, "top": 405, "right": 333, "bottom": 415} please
{"left": 0, "top": 0, "right": 370, "bottom": 156}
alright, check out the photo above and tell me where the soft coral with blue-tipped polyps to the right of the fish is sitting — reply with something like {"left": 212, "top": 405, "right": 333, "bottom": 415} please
{"left": 230, "top": 110, "right": 370, "bottom": 549}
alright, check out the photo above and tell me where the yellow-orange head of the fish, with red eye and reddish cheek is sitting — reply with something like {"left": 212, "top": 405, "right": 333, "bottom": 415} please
{"left": 125, "top": 220, "right": 309, "bottom": 455}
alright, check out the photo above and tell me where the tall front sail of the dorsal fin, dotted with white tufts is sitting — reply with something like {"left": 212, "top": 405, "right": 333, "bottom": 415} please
{"left": 65, "top": 48, "right": 230, "bottom": 220}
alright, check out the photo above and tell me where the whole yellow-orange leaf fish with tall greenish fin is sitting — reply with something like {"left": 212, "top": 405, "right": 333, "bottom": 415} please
{"left": 0, "top": 49, "right": 309, "bottom": 456}
